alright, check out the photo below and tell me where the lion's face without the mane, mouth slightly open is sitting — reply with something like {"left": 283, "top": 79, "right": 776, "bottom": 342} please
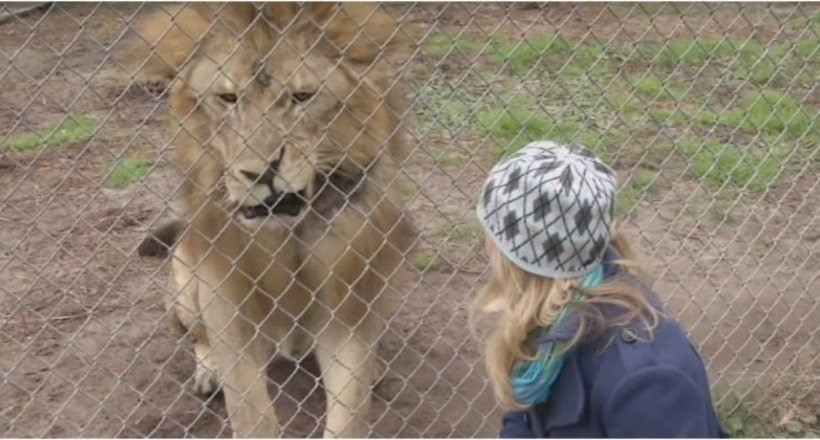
{"left": 180, "top": 33, "right": 366, "bottom": 227}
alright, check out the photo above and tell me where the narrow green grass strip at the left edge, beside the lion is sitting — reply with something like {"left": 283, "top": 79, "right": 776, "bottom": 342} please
{"left": 0, "top": 113, "right": 100, "bottom": 153}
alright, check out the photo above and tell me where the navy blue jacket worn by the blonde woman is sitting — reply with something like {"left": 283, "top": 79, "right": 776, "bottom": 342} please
{"left": 501, "top": 252, "right": 728, "bottom": 438}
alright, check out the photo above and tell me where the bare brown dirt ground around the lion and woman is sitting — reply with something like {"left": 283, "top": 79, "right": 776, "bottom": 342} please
{"left": 0, "top": 3, "right": 820, "bottom": 437}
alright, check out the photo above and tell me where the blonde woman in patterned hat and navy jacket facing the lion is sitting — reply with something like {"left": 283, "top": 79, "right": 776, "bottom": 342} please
{"left": 475, "top": 142, "right": 726, "bottom": 438}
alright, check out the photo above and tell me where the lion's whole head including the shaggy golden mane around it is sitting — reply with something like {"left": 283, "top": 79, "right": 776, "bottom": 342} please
{"left": 161, "top": 2, "right": 414, "bottom": 229}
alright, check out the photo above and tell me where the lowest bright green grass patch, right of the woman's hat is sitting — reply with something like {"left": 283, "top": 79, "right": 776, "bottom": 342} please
{"left": 676, "top": 139, "right": 781, "bottom": 193}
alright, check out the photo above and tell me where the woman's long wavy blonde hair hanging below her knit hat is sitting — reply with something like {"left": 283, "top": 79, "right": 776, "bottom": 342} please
{"left": 471, "top": 233, "right": 660, "bottom": 410}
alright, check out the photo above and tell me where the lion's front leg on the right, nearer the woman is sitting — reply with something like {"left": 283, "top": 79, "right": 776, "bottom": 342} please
{"left": 316, "top": 322, "right": 376, "bottom": 438}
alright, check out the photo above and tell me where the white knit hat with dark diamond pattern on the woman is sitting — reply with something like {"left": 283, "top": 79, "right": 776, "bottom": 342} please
{"left": 477, "top": 141, "right": 616, "bottom": 278}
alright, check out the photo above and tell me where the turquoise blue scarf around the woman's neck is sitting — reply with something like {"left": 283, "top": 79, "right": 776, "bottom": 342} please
{"left": 511, "top": 265, "right": 604, "bottom": 406}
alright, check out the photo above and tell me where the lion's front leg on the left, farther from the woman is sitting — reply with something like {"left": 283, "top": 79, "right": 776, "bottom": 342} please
{"left": 202, "top": 282, "right": 280, "bottom": 438}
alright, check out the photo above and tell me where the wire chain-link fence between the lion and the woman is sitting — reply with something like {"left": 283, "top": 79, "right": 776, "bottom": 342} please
{"left": 0, "top": 3, "right": 820, "bottom": 437}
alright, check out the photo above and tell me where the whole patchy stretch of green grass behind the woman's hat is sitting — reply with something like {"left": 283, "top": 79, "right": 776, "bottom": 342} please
{"left": 416, "top": 29, "right": 820, "bottom": 223}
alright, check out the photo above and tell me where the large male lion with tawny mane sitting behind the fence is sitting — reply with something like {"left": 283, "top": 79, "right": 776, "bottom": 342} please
{"left": 129, "top": 3, "right": 416, "bottom": 437}
